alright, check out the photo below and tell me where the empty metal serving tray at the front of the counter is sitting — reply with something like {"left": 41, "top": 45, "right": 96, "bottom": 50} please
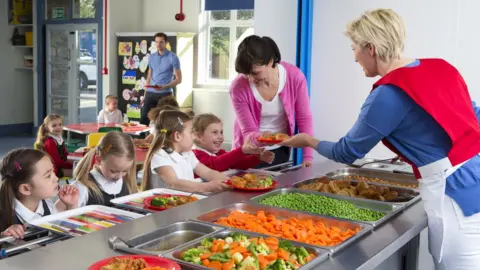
{"left": 109, "top": 221, "right": 224, "bottom": 256}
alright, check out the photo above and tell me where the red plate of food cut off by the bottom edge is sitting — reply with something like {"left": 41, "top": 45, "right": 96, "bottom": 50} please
{"left": 88, "top": 255, "right": 181, "bottom": 270}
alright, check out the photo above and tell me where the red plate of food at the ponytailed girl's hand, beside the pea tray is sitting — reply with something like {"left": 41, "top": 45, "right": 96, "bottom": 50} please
{"left": 226, "top": 173, "right": 277, "bottom": 191}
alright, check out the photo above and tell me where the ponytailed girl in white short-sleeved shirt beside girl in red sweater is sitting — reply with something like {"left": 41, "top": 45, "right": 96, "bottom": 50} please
{"left": 142, "top": 110, "right": 228, "bottom": 193}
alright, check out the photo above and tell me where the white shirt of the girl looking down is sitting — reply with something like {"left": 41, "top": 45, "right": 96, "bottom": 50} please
{"left": 72, "top": 168, "right": 123, "bottom": 207}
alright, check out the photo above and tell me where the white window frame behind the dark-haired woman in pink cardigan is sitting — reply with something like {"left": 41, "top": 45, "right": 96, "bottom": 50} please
{"left": 197, "top": 4, "right": 255, "bottom": 86}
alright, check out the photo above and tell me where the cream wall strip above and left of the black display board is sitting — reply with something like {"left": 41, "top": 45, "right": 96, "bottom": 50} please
{"left": 100, "top": 0, "right": 144, "bottom": 100}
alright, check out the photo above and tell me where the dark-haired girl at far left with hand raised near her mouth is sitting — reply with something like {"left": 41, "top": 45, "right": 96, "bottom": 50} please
{"left": 0, "top": 148, "right": 78, "bottom": 238}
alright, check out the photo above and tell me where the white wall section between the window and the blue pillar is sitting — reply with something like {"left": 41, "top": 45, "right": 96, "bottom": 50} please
{"left": 254, "top": 0, "right": 296, "bottom": 64}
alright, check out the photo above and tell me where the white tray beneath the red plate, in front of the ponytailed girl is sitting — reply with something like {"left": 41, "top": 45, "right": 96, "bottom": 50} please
{"left": 110, "top": 188, "right": 207, "bottom": 213}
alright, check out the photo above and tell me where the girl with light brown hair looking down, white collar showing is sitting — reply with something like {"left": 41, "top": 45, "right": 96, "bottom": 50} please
{"left": 59, "top": 131, "right": 137, "bottom": 207}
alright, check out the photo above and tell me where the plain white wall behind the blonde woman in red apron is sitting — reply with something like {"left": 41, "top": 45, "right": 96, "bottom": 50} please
{"left": 310, "top": 0, "right": 480, "bottom": 160}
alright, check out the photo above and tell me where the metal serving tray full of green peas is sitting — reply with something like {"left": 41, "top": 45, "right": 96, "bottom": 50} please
{"left": 251, "top": 188, "right": 404, "bottom": 226}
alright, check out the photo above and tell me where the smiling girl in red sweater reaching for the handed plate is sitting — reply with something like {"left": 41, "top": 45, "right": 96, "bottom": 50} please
{"left": 193, "top": 113, "right": 275, "bottom": 172}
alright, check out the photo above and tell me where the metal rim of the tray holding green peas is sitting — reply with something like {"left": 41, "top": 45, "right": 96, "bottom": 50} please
{"left": 250, "top": 188, "right": 405, "bottom": 227}
